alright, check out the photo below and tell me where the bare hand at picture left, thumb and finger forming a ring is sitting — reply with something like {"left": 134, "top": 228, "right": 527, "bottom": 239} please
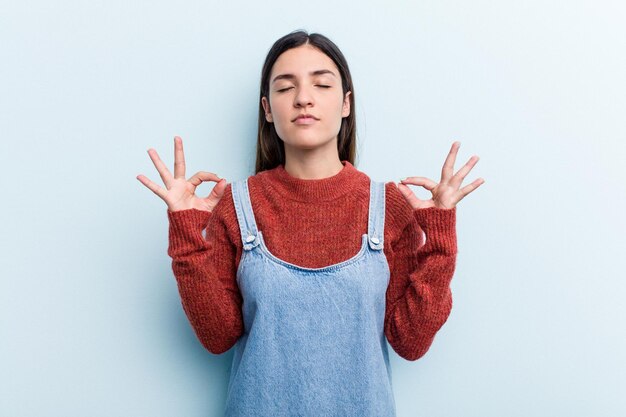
{"left": 137, "top": 136, "right": 227, "bottom": 212}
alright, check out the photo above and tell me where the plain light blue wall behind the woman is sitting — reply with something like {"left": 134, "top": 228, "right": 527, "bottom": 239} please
{"left": 0, "top": 0, "right": 626, "bottom": 417}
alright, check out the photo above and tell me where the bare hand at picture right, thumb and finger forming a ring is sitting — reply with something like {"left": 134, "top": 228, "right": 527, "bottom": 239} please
{"left": 398, "top": 141, "right": 485, "bottom": 209}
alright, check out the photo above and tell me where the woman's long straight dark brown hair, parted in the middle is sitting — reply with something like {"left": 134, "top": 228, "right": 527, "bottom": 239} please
{"left": 255, "top": 30, "right": 356, "bottom": 174}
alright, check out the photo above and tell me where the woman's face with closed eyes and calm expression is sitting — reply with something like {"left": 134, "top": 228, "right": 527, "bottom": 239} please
{"left": 261, "top": 44, "right": 351, "bottom": 153}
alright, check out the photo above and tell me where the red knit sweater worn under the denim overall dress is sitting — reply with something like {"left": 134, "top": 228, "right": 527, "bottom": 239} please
{"left": 167, "top": 161, "right": 457, "bottom": 360}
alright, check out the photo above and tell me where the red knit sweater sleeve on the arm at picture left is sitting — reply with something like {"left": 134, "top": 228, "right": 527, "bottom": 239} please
{"left": 167, "top": 203, "right": 244, "bottom": 354}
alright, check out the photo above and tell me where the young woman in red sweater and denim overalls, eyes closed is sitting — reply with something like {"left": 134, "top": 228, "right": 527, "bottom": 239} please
{"left": 137, "top": 31, "right": 483, "bottom": 417}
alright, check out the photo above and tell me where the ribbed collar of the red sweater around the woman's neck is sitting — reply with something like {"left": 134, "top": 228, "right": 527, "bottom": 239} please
{"left": 261, "top": 160, "right": 368, "bottom": 202}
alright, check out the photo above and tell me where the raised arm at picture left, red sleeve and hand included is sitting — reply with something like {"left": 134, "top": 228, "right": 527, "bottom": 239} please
{"left": 137, "top": 136, "right": 243, "bottom": 354}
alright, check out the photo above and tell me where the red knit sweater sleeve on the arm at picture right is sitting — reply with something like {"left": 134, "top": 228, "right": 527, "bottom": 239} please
{"left": 385, "top": 203, "right": 457, "bottom": 361}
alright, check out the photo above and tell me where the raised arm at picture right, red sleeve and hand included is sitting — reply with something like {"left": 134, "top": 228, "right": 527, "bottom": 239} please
{"left": 385, "top": 141, "right": 485, "bottom": 360}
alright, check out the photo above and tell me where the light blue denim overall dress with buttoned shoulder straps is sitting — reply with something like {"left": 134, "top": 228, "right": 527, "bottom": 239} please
{"left": 225, "top": 176, "right": 396, "bottom": 417}
